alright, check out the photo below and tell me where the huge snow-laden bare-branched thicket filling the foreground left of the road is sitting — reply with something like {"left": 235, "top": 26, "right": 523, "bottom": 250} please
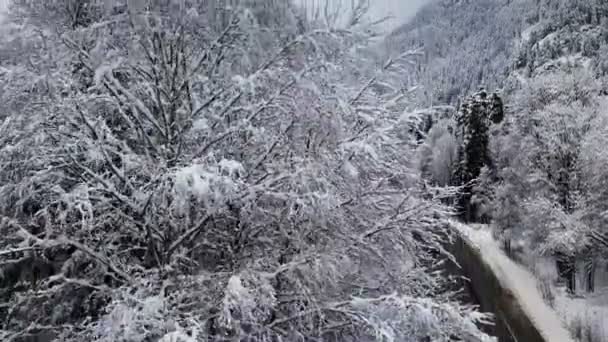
{"left": 0, "top": 0, "right": 484, "bottom": 342}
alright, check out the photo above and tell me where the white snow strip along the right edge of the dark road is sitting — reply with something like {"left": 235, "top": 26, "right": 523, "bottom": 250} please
{"left": 454, "top": 222, "right": 574, "bottom": 342}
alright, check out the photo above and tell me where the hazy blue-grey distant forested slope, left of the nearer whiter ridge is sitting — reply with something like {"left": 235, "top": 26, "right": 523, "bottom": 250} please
{"left": 386, "top": 0, "right": 535, "bottom": 105}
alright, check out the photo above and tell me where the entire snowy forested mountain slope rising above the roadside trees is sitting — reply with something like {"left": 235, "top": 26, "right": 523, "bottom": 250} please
{"left": 387, "top": 0, "right": 608, "bottom": 104}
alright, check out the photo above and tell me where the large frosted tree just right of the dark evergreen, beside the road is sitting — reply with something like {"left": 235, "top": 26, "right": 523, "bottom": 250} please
{"left": 493, "top": 71, "right": 601, "bottom": 291}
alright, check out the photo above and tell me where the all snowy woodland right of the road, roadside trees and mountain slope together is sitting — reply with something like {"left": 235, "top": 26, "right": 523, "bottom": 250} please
{"left": 402, "top": 0, "right": 608, "bottom": 341}
